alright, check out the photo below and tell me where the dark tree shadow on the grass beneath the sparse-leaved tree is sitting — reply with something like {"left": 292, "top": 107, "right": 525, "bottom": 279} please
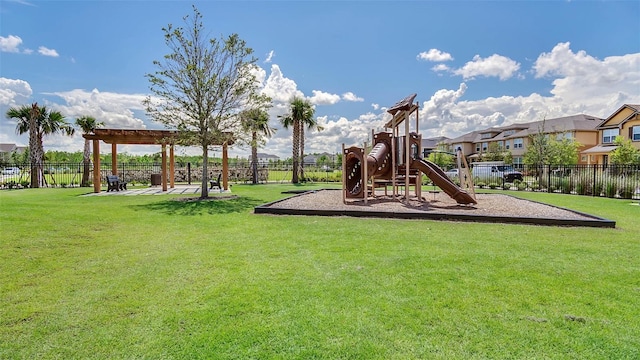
{"left": 134, "top": 197, "right": 264, "bottom": 215}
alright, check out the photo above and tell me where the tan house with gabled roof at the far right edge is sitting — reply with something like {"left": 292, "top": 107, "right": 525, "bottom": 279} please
{"left": 580, "top": 104, "right": 640, "bottom": 165}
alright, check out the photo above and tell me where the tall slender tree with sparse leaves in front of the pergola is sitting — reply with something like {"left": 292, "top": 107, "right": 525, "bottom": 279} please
{"left": 144, "top": 6, "right": 269, "bottom": 198}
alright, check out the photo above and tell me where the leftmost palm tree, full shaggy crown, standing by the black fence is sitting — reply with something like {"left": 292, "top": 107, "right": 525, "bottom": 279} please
{"left": 6, "top": 103, "right": 75, "bottom": 187}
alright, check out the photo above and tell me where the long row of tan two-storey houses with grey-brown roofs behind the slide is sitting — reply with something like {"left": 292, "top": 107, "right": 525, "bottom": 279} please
{"left": 446, "top": 114, "right": 602, "bottom": 165}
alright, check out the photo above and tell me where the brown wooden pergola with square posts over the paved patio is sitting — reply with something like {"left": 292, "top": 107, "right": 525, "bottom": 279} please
{"left": 82, "top": 129, "right": 231, "bottom": 193}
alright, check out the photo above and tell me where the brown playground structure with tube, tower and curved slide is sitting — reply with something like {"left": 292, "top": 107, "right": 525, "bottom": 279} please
{"left": 342, "top": 94, "right": 477, "bottom": 205}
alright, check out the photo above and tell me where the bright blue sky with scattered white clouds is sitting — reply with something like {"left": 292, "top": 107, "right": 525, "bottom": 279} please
{"left": 0, "top": 0, "right": 640, "bottom": 157}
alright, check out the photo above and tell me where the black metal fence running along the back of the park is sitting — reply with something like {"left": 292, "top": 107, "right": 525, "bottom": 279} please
{"left": 0, "top": 159, "right": 640, "bottom": 199}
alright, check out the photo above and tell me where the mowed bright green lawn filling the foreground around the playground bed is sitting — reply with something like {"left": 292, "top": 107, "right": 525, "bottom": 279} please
{"left": 0, "top": 184, "right": 640, "bottom": 359}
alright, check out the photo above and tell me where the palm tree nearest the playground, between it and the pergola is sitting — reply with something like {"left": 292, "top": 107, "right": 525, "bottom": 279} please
{"left": 280, "top": 96, "right": 315, "bottom": 184}
